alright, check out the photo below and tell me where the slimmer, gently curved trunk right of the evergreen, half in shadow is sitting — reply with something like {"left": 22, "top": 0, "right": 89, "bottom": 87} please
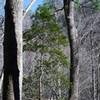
{"left": 63, "top": 0, "right": 79, "bottom": 100}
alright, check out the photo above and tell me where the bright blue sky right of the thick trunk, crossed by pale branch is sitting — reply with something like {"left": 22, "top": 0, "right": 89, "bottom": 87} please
{"left": 24, "top": 0, "right": 44, "bottom": 12}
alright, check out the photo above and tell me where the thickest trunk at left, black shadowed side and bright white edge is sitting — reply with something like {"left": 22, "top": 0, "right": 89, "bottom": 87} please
{"left": 2, "top": 0, "right": 23, "bottom": 100}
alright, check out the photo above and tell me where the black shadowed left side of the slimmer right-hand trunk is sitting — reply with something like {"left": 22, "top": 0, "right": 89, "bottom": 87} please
{"left": 63, "top": 0, "right": 74, "bottom": 98}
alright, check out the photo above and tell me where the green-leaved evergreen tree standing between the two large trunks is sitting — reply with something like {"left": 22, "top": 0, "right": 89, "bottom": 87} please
{"left": 24, "top": 4, "right": 70, "bottom": 97}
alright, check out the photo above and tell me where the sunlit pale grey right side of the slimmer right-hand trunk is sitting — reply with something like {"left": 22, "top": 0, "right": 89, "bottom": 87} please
{"left": 70, "top": 1, "right": 79, "bottom": 100}
